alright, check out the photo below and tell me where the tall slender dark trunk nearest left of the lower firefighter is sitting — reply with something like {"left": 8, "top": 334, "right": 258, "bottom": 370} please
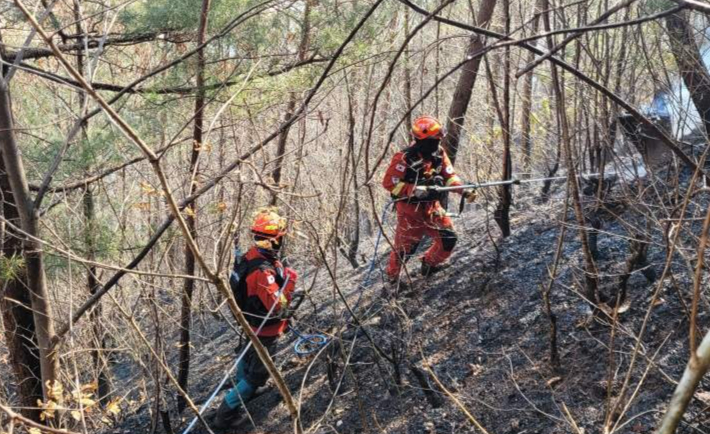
{"left": 177, "top": 0, "right": 211, "bottom": 412}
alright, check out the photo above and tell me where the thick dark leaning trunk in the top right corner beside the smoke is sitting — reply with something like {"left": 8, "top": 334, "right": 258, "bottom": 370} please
{"left": 666, "top": 11, "right": 710, "bottom": 134}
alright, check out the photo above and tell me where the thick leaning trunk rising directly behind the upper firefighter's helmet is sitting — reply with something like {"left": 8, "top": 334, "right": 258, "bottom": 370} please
{"left": 443, "top": 0, "right": 496, "bottom": 163}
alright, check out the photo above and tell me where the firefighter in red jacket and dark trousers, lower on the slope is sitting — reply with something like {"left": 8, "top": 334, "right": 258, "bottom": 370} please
{"left": 213, "top": 210, "right": 297, "bottom": 429}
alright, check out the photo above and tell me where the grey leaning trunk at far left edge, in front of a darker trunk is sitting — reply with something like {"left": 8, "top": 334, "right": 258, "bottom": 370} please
{"left": 0, "top": 78, "right": 59, "bottom": 402}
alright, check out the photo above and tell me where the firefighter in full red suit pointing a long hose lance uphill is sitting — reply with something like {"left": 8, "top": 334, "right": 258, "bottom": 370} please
{"left": 382, "top": 116, "right": 476, "bottom": 283}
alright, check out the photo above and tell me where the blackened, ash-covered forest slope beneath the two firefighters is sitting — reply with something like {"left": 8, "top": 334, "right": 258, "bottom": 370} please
{"left": 85, "top": 171, "right": 710, "bottom": 434}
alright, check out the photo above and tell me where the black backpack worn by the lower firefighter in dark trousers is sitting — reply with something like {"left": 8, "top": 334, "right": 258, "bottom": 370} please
{"left": 229, "top": 255, "right": 284, "bottom": 327}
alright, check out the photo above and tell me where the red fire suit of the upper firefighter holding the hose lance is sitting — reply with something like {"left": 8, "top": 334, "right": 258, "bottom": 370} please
{"left": 382, "top": 148, "right": 462, "bottom": 279}
